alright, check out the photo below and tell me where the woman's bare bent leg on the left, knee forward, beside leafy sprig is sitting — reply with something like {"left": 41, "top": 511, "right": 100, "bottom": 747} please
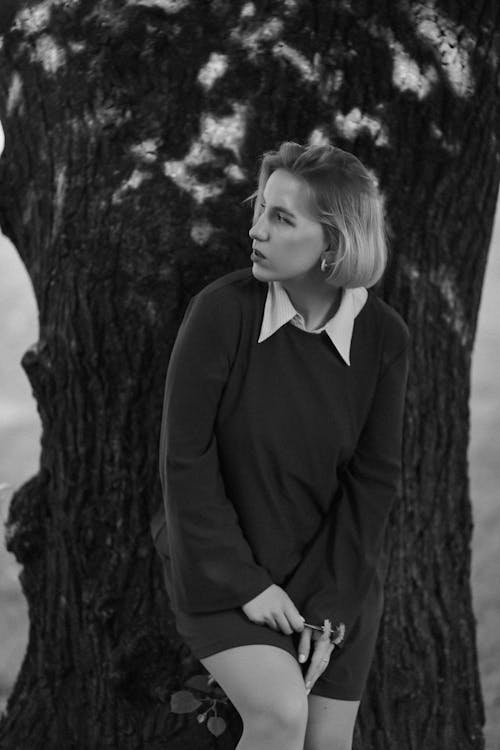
{"left": 200, "top": 644, "right": 308, "bottom": 750}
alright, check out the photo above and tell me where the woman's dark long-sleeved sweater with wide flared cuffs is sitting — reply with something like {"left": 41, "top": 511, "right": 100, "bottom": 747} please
{"left": 151, "top": 268, "right": 410, "bottom": 631}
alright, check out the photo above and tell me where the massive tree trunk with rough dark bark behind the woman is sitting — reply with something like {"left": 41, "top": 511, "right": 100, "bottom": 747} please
{"left": 0, "top": 0, "right": 500, "bottom": 750}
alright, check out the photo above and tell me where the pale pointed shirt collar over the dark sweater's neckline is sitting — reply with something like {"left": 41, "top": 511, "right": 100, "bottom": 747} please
{"left": 258, "top": 281, "right": 368, "bottom": 365}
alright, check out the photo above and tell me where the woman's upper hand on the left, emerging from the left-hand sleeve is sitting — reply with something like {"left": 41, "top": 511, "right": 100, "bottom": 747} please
{"left": 241, "top": 583, "right": 304, "bottom": 635}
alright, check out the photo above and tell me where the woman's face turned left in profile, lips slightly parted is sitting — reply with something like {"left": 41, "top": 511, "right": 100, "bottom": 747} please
{"left": 248, "top": 169, "right": 328, "bottom": 281}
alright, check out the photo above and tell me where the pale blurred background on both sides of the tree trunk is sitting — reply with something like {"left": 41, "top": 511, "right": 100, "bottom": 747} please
{"left": 0, "top": 203, "right": 500, "bottom": 750}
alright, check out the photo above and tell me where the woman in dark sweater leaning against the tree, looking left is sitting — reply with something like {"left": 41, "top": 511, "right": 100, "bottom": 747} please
{"left": 152, "top": 142, "right": 409, "bottom": 750}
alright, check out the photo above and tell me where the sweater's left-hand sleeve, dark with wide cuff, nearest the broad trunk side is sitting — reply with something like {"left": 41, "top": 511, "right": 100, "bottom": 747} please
{"left": 153, "top": 289, "right": 273, "bottom": 613}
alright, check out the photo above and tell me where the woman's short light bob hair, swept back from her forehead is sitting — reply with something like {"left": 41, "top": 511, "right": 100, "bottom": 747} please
{"left": 245, "top": 141, "right": 388, "bottom": 288}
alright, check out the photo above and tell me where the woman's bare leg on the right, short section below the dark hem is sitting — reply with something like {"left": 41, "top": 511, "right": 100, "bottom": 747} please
{"left": 304, "top": 695, "right": 360, "bottom": 750}
